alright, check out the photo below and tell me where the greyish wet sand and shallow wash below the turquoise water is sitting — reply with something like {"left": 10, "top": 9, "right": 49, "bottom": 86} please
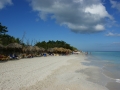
{"left": 83, "top": 56, "right": 120, "bottom": 90}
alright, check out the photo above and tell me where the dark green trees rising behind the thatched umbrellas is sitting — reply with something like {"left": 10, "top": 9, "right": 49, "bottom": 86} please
{"left": 0, "top": 23, "right": 77, "bottom": 51}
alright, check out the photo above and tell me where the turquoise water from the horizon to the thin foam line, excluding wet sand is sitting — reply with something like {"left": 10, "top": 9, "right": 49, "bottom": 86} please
{"left": 91, "top": 51, "right": 120, "bottom": 81}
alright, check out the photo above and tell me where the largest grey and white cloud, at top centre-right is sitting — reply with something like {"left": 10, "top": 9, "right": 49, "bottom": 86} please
{"left": 29, "top": 0, "right": 113, "bottom": 33}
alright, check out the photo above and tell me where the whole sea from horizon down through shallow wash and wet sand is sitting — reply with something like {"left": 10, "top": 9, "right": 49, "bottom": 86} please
{"left": 82, "top": 51, "right": 120, "bottom": 90}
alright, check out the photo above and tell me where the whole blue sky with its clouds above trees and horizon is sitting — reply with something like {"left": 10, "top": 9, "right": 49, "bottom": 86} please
{"left": 0, "top": 0, "right": 120, "bottom": 51}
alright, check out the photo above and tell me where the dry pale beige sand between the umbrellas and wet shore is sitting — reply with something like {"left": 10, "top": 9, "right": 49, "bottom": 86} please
{"left": 0, "top": 55, "right": 108, "bottom": 90}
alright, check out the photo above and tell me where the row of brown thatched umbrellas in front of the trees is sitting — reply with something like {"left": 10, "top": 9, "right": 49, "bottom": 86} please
{"left": 0, "top": 43, "right": 72, "bottom": 53}
